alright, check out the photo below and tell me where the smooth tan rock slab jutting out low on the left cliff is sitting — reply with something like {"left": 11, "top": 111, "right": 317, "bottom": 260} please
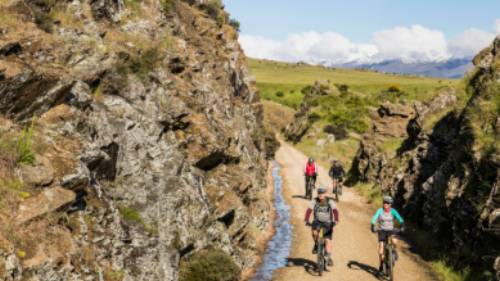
{"left": 14, "top": 187, "right": 76, "bottom": 224}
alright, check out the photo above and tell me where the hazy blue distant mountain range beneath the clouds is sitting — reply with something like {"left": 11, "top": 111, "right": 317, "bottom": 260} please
{"left": 335, "top": 58, "right": 472, "bottom": 78}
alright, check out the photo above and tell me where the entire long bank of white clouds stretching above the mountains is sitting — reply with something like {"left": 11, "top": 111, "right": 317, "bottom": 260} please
{"left": 240, "top": 19, "right": 500, "bottom": 65}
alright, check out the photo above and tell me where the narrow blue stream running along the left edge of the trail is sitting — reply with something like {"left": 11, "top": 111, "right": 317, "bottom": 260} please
{"left": 251, "top": 162, "right": 292, "bottom": 281}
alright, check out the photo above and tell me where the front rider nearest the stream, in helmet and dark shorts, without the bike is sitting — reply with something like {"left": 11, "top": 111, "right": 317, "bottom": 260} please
{"left": 305, "top": 186, "right": 339, "bottom": 266}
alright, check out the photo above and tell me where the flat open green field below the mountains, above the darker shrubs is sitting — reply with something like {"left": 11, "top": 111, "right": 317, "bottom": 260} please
{"left": 248, "top": 59, "right": 458, "bottom": 109}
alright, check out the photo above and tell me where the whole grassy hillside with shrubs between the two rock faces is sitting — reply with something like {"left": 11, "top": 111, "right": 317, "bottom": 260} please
{"left": 249, "top": 59, "right": 459, "bottom": 171}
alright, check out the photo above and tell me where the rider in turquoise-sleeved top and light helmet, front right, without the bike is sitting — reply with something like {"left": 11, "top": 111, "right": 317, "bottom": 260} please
{"left": 371, "top": 196, "right": 404, "bottom": 271}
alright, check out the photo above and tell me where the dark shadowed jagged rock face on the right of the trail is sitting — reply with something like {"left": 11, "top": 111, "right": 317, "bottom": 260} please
{"left": 364, "top": 37, "right": 500, "bottom": 270}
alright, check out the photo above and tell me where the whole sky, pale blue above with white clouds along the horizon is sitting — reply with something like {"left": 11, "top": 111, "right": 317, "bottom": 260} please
{"left": 224, "top": 0, "right": 500, "bottom": 65}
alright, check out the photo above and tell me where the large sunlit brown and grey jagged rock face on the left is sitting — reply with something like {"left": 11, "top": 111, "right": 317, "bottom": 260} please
{"left": 0, "top": 0, "right": 270, "bottom": 281}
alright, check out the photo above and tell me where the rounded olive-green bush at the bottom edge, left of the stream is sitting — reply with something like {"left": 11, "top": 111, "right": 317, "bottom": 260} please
{"left": 179, "top": 250, "right": 241, "bottom": 281}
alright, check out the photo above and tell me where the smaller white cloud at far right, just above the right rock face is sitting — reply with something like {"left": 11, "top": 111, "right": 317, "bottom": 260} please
{"left": 450, "top": 28, "right": 495, "bottom": 58}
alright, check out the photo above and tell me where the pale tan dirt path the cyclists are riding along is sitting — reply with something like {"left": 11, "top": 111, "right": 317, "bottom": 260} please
{"left": 274, "top": 143, "right": 435, "bottom": 281}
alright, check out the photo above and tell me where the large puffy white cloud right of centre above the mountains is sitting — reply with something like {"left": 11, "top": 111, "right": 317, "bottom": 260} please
{"left": 373, "top": 25, "right": 451, "bottom": 63}
